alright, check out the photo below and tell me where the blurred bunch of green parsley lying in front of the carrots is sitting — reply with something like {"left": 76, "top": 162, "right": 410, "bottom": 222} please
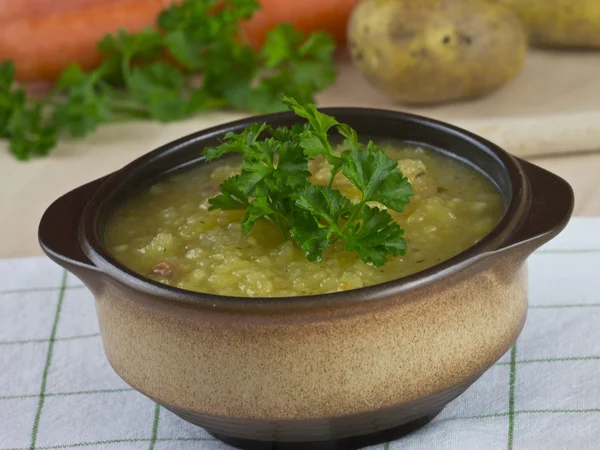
{"left": 0, "top": 0, "right": 336, "bottom": 160}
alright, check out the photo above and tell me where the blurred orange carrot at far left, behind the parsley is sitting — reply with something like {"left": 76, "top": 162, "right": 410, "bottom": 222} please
{"left": 0, "top": 0, "right": 173, "bottom": 82}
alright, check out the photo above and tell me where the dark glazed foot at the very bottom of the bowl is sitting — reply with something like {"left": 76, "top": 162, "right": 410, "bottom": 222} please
{"left": 209, "top": 409, "right": 442, "bottom": 450}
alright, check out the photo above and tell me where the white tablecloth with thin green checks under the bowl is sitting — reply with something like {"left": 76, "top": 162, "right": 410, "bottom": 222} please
{"left": 0, "top": 218, "right": 600, "bottom": 450}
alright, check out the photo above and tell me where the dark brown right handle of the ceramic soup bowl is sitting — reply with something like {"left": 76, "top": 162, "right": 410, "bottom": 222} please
{"left": 503, "top": 158, "right": 575, "bottom": 250}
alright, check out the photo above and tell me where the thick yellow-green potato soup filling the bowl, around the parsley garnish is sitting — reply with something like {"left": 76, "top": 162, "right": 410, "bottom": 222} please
{"left": 106, "top": 144, "right": 504, "bottom": 297}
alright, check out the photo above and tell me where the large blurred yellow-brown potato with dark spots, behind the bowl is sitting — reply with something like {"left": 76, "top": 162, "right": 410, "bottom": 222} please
{"left": 348, "top": 0, "right": 524, "bottom": 104}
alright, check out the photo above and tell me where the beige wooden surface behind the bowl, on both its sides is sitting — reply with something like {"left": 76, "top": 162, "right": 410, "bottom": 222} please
{"left": 0, "top": 48, "right": 600, "bottom": 258}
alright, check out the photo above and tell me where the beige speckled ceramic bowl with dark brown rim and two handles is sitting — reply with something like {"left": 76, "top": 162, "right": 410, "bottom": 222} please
{"left": 40, "top": 108, "right": 573, "bottom": 448}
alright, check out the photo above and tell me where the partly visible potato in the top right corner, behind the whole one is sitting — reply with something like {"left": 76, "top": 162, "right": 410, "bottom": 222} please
{"left": 492, "top": 0, "right": 600, "bottom": 48}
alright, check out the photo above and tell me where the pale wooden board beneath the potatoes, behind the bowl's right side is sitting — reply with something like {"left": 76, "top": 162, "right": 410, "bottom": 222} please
{"left": 319, "top": 50, "right": 600, "bottom": 157}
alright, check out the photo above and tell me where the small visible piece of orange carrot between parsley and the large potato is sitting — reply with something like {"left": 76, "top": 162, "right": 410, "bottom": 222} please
{"left": 243, "top": 0, "right": 360, "bottom": 48}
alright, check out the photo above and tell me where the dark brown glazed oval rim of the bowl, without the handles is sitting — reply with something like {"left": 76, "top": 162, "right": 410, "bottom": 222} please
{"left": 69, "top": 108, "right": 544, "bottom": 309}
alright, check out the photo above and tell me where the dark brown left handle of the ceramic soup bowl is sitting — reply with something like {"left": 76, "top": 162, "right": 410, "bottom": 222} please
{"left": 38, "top": 177, "right": 107, "bottom": 278}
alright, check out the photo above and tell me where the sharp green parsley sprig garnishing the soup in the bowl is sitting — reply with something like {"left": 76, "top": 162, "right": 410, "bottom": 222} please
{"left": 204, "top": 97, "right": 413, "bottom": 266}
